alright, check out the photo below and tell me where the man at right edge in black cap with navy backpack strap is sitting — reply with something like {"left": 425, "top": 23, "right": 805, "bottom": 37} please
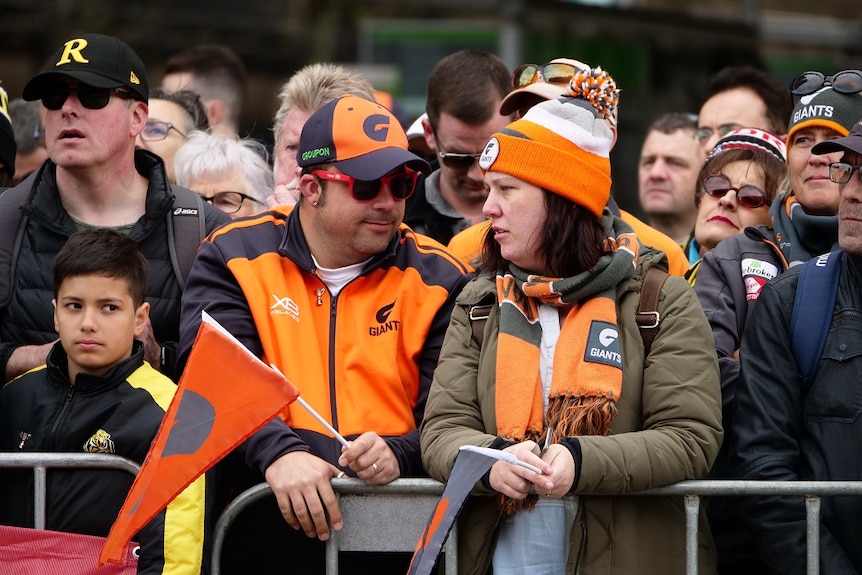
{"left": 729, "top": 123, "right": 862, "bottom": 573}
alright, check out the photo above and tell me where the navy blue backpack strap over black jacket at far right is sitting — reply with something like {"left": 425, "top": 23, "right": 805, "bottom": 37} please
{"left": 790, "top": 250, "right": 842, "bottom": 394}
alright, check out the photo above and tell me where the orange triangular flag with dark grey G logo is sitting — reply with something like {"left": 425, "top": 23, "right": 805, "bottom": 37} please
{"left": 99, "top": 312, "right": 299, "bottom": 565}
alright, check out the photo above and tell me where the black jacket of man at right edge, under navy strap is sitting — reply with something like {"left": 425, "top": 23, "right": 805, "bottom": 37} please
{"left": 729, "top": 254, "right": 862, "bottom": 575}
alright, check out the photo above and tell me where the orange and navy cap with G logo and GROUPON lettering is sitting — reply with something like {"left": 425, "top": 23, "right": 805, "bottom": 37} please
{"left": 296, "top": 95, "right": 431, "bottom": 181}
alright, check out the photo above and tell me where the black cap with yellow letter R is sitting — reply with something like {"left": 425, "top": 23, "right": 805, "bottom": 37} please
{"left": 22, "top": 34, "right": 150, "bottom": 102}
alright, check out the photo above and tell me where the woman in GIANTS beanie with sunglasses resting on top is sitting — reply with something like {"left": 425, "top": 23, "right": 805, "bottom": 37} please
{"left": 695, "top": 74, "right": 862, "bottom": 575}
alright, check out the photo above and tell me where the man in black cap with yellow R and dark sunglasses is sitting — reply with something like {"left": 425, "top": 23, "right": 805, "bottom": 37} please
{"left": 0, "top": 34, "right": 229, "bottom": 380}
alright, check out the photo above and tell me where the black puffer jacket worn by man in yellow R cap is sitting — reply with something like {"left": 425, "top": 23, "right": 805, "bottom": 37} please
{"left": 0, "top": 150, "right": 229, "bottom": 380}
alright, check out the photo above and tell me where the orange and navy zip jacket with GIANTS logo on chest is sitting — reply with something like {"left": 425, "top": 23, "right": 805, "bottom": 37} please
{"left": 180, "top": 208, "right": 472, "bottom": 476}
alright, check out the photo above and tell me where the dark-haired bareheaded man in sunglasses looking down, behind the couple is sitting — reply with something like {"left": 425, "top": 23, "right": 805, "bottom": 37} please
{"left": 404, "top": 50, "right": 513, "bottom": 244}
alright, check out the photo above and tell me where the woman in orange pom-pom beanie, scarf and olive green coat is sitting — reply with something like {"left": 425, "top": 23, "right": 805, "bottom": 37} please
{"left": 421, "top": 70, "right": 721, "bottom": 575}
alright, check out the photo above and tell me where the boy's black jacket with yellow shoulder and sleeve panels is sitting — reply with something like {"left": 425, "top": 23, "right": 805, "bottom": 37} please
{"left": 0, "top": 342, "right": 205, "bottom": 575}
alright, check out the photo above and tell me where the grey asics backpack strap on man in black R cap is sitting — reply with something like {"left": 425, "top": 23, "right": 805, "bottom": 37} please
{"left": 167, "top": 186, "right": 206, "bottom": 286}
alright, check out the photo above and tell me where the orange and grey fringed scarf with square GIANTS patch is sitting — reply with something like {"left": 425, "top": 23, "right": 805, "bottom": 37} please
{"left": 495, "top": 211, "right": 640, "bottom": 513}
